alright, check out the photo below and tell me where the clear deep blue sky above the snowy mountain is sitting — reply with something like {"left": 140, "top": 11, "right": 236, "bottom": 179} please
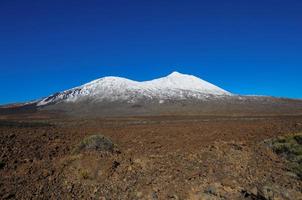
{"left": 0, "top": 0, "right": 302, "bottom": 104}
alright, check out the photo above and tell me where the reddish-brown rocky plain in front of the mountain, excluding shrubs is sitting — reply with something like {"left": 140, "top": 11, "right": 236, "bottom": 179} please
{"left": 0, "top": 116, "right": 302, "bottom": 200}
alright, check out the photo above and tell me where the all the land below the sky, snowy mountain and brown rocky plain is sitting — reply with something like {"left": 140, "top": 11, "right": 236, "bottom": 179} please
{"left": 0, "top": 72, "right": 302, "bottom": 200}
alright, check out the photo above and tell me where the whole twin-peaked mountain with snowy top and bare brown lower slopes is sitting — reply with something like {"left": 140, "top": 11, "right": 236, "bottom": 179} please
{"left": 0, "top": 72, "right": 302, "bottom": 116}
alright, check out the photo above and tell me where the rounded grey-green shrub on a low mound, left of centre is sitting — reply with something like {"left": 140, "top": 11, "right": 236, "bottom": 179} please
{"left": 74, "top": 134, "right": 116, "bottom": 153}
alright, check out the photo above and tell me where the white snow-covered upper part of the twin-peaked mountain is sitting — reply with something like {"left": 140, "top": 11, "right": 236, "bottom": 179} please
{"left": 37, "top": 72, "right": 232, "bottom": 106}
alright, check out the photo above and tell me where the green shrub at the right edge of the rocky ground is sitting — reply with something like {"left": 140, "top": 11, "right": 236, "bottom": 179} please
{"left": 270, "top": 133, "right": 302, "bottom": 179}
